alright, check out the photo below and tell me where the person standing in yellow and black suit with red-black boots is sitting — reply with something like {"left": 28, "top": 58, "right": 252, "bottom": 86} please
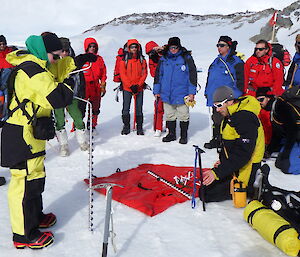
{"left": 1, "top": 33, "right": 75, "bottom": 249}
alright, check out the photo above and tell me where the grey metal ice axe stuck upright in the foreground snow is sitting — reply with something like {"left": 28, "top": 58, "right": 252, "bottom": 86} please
{"left": 92, "top": 183, "right": 124, "bottom": 257}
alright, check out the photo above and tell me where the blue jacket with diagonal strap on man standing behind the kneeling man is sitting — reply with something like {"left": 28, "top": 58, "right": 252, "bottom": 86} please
{"left": 204, "top": 51, "right": 244, "bottom": 106}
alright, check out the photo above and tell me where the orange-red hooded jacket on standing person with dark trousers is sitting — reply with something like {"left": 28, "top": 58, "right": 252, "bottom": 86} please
{"left": 120, "top": 39, "right": 148, "bottom": 92}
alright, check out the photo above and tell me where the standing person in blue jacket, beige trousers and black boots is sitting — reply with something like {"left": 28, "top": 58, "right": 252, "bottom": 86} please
{"left": 153, "top": 37, "right": 197, "bottom": 144}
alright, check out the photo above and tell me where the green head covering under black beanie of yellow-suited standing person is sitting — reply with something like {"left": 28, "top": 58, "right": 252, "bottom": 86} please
{"left": 25, "top": 35, "right": 48, "bottom": 61}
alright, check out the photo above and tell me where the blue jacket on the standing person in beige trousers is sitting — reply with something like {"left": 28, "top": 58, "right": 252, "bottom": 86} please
{"left": 153, "top": 48, "right": 197, "bottom": 104}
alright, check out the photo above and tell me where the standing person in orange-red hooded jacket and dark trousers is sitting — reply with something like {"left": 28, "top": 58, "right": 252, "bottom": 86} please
{"left": 120, "top": 39, "right": 147, "bottom": 135}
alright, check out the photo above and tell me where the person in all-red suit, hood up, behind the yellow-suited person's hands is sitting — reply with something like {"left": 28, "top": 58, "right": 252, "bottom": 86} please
{"left": 82, "top": 38, "right": 107, "bottom": 130}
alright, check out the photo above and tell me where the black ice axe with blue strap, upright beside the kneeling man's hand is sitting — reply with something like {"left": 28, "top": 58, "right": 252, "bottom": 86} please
{"left": 192, "top": 145, "right": 206, "bottom": 211}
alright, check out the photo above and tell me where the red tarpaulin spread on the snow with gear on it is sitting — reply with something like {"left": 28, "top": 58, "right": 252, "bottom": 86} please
{"left": 85, "top": 164, "right": 205, "bottom": 216}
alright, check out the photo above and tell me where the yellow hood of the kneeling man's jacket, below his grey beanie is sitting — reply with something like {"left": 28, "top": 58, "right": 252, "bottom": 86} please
{"left": 227, "top": 95, "right": 261, "bottom": 115}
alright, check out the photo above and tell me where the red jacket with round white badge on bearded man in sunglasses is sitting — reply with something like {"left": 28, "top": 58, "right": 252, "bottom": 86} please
{"left": 244, "top": 44, "right": 284, "bottom": 97}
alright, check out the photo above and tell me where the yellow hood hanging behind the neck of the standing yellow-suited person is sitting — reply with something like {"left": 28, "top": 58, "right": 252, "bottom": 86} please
{"left": 6, "top": 50, "right": 47, "bottom": 68}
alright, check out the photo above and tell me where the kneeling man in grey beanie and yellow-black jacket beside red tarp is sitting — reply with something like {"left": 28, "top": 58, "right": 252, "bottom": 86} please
{"left": 203, "top": 86, "right": 265, "bottom": 202}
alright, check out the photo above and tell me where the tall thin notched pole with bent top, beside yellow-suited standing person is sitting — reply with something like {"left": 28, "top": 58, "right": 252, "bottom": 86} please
{"left": 74, "top": 96, "right": 95, "bottom": 231}
